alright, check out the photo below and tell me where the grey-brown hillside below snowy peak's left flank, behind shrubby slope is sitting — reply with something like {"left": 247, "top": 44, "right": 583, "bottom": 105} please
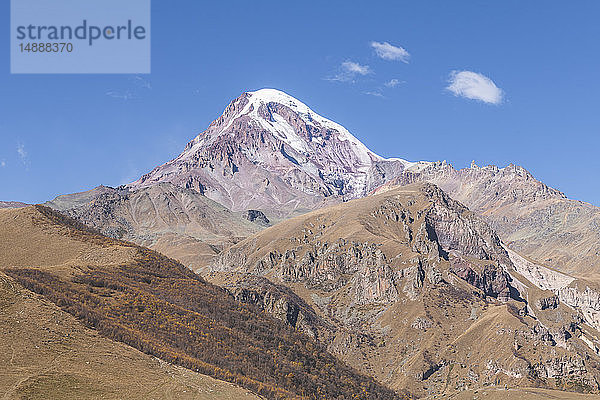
{"left": 45, "top": 183, "right": 262, "bottom": 269}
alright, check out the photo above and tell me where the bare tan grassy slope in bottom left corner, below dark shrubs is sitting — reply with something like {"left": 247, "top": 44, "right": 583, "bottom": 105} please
{"left": 0, "top": 270, "right": 259, "bottom": 400}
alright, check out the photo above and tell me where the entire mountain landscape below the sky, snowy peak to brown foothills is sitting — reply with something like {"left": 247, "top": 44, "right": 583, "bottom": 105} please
{"left": 0, "top": 89, "right": 600, "bottom": 399}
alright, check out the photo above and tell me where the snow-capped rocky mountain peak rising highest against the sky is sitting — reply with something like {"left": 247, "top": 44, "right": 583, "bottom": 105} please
{"left": 129, "top": 89, "right": 414, "bottom": 216}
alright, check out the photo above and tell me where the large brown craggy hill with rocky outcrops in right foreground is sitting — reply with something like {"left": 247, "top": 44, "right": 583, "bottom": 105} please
{"left": 210, "top": 184, "right": 600, "bottom": 396}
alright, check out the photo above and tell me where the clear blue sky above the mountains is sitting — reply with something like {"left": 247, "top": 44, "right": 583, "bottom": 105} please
{"left": 0, "top": 0, "right": 600, "bottom": 205}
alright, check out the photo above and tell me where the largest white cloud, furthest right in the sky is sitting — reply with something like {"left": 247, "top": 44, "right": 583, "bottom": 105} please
{"left": 446, "top": 71, "right": 504, "bottom": 104}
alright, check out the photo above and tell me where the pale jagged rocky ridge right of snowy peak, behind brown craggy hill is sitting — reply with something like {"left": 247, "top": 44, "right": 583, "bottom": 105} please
{"left": 376, "top": 162, "right": 600, "bottom": 273}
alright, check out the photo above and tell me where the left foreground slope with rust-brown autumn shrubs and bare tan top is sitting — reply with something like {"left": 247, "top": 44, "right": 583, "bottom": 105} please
{"left": 0, "top": 206, "right": 400, "bottom": 399}
